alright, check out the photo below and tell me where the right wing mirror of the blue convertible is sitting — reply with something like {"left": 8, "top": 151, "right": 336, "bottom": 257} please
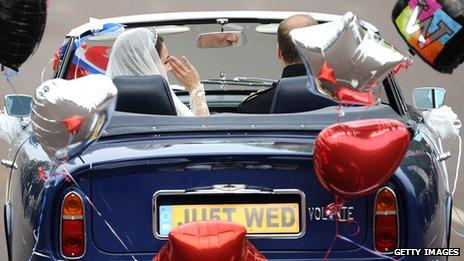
{"left": 412, "top": 87, "right": 446, "bottom": 110}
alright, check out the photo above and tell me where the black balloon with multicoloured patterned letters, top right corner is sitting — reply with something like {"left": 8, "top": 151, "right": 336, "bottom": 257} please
{"left": 392, "top": 0, "right": 464, "bottom": 73}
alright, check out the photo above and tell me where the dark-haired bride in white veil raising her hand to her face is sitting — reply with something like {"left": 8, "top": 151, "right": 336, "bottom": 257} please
{"left": 106, "top": 28, "right": 210, "bottom": 116}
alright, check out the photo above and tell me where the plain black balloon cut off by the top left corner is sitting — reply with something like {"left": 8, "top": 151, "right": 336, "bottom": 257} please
{"left": 0, "top": 0, "right": 48, "bottom": 71}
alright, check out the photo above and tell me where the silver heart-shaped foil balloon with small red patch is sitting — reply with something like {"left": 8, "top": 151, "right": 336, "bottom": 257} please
{"left": 31, "top": 75, "right": 117, "bottom": 163}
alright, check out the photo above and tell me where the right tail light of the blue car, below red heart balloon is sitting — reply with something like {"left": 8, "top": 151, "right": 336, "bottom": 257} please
{"left": 374, "top": 187, "right": 399, "bottom": 253}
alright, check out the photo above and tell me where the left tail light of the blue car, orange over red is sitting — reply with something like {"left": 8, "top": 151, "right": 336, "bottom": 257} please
{"left": 60, "top": 192, "right": 86, "bottom": 259}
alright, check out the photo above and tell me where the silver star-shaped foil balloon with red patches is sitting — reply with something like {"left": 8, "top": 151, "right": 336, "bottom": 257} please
{"left": 290, "top": 12, "right": 407, "bottom": 103}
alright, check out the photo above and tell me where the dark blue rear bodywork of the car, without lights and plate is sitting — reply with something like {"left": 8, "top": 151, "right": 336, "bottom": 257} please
{"left": 4, "top": 10, "right": 452, "bottom": 260}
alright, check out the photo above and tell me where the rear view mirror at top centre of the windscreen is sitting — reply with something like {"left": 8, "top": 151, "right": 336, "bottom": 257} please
{"left": 197, "top": 31, "right": 246, "bottom": 49}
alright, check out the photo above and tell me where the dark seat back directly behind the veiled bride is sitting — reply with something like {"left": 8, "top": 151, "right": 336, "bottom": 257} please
{"left": 113, "top": 75, "right": 177, "bottom": 115}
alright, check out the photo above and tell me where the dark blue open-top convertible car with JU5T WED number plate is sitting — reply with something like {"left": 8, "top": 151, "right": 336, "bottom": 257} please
{"left": 1, "top": 12, "right": 452, "bottom": 260}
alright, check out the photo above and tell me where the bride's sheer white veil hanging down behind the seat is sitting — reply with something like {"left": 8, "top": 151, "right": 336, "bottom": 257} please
{"left": 106, "top": 28, "right": 194, "bottom": 116}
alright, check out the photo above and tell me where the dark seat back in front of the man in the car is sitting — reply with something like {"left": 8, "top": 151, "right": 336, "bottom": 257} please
{"left": 271, "top": 76, "right": 338, "bottom": 113}
